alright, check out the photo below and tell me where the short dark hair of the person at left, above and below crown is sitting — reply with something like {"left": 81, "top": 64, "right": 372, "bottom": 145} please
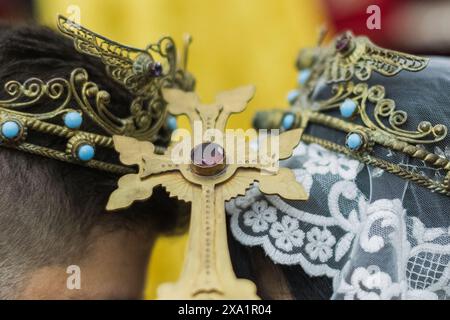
{"left": 0, "top": 25, "right": 187, "bottom": 298}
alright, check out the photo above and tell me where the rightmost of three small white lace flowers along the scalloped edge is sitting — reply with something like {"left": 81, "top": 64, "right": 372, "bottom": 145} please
{"left": 305, "top": 227, "right": 336, "bottom": 263}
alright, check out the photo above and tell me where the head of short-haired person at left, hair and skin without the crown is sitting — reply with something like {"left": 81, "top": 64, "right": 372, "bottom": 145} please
{"left": 0, "top": 26, "right": 186, "bottom": 299}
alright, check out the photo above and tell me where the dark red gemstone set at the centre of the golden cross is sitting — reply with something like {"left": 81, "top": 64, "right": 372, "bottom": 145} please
{"left": 191, "top": 142, "right": 225, "bottom": 175}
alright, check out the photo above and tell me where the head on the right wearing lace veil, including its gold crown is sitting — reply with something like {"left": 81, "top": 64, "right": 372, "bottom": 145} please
{"left": 236, "top": 34, "right": 450, "bottom": 299}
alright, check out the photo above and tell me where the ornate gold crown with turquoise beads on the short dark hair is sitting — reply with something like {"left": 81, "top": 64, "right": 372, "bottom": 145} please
{"left": 0, "top": 16, "right": 195, "bottom": 173}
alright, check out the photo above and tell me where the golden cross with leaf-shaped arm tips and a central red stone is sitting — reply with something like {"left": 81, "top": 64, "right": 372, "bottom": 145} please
{"left": 107, "top": 86, "right": 308, "bottom": 300}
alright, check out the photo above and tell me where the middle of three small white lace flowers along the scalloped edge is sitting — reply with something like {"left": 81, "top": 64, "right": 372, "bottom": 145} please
{"left": 270, "top": 216, "right": 305, "bottom": 252}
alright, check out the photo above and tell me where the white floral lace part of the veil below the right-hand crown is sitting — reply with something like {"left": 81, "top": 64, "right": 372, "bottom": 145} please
{"left": 227, "top": 144, "right": 450, "bottom": 300}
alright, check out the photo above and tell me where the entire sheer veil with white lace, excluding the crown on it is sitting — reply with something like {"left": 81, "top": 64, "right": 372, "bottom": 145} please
{"left": 227, "top": 57, "right": 450, "bottom": 299}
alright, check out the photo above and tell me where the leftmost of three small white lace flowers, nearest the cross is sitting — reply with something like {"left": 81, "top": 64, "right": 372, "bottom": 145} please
{"left": 244, "top": 200, "right": 277, "bottom": 233}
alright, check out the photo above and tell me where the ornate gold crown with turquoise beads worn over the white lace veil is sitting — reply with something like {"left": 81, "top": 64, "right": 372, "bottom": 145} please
{"left": 254, "top": 32, "right": 450, "bottom": 196}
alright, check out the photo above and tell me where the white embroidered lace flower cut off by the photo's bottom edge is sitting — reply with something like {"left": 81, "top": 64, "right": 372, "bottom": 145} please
{"left": 338, "top": 266, "right": 401, "bottom": 300}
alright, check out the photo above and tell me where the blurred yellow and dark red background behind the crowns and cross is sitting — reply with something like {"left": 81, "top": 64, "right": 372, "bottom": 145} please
{"left": 0, "top": 0, "right": 450, "bottom": 299}
